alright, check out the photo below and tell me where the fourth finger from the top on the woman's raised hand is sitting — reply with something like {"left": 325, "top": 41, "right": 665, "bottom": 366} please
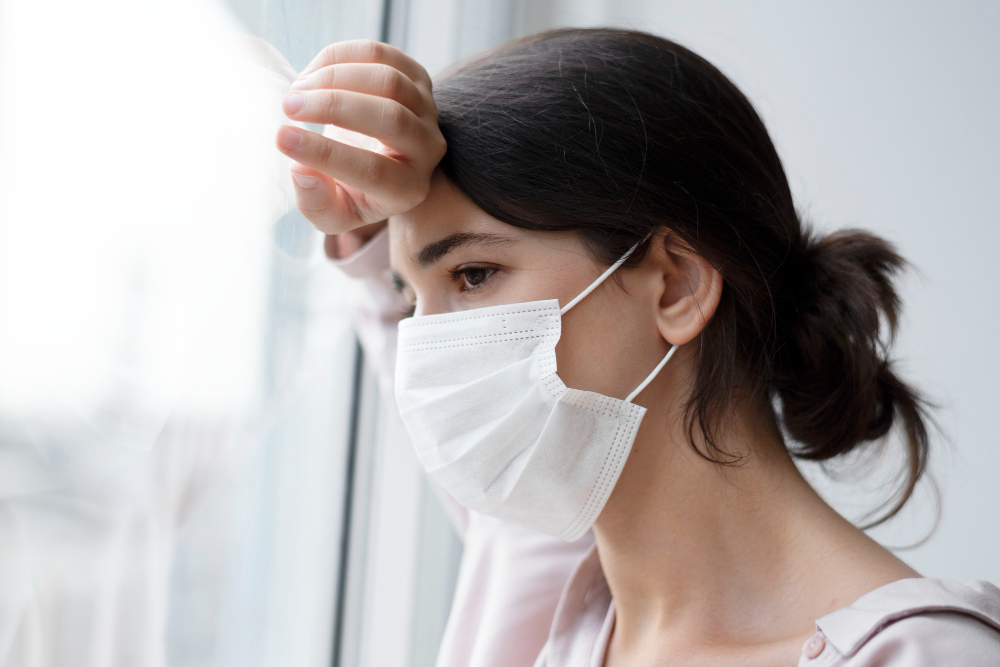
{"left": 277, "top": 125, "right": 416, "bottom": 209}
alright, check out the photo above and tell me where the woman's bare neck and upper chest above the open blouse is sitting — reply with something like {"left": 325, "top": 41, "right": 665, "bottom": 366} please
{"left": 594, "top": 380, "right": 915, "bottom": 646}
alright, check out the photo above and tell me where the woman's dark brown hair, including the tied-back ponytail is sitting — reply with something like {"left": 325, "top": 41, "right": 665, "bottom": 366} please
{"left": 434, "top": 28, "right": 932, "bottom": 525}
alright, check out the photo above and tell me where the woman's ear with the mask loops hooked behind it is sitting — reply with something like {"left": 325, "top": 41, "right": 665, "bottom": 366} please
{"left": 650, "top": 231, "right": 722, "bottom": 345}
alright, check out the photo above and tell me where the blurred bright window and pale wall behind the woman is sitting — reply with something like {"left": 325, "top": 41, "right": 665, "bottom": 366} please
{"left": 0, "top": 0, "right": 1000, "bottom": 667}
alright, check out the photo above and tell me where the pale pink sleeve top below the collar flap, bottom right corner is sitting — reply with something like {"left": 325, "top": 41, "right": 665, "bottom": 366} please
{"left": 844, "top": 611, "right": 1000, "bottom": 667}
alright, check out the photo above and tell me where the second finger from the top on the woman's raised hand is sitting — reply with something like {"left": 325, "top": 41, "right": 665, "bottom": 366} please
{"left": 292, "top": 63, "right": 428, "bottom": 115}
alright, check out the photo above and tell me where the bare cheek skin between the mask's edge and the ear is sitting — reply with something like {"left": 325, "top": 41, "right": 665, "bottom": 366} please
{"left": 556, "top": 287, "right": 662, "bottom": 399}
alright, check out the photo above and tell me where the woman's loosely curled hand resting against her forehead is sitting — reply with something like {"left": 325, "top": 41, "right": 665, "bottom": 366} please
{"left": 277, "top": 40, "right": 447, "bottom": 237}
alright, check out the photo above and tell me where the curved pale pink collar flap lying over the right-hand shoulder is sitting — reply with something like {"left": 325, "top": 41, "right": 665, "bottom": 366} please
{"left": 816, "top": 577, "right": 1000, "bottom": 657}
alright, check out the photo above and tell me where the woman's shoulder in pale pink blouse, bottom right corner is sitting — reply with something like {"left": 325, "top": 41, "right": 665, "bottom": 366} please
{"left": 800, "top": 577, "right": 1000, "bottom": 667}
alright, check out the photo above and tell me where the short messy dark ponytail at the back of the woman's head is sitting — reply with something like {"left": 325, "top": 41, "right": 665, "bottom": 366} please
{"left": 773, "top": 229, "right": 933, "bottom": 525}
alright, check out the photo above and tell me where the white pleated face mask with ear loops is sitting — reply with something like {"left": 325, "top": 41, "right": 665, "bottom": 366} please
{"left": 395, "top": 232, "right": 677, "bottom": 540}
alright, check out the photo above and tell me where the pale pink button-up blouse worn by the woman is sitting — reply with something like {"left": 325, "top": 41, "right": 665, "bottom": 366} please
{"left": 332, "top": 229, "right": 1000, "bottom": 667}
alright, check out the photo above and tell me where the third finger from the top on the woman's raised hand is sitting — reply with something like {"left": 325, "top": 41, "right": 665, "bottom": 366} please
{"left": 282, "top": 90, "right": 427, "bottom": 155}
